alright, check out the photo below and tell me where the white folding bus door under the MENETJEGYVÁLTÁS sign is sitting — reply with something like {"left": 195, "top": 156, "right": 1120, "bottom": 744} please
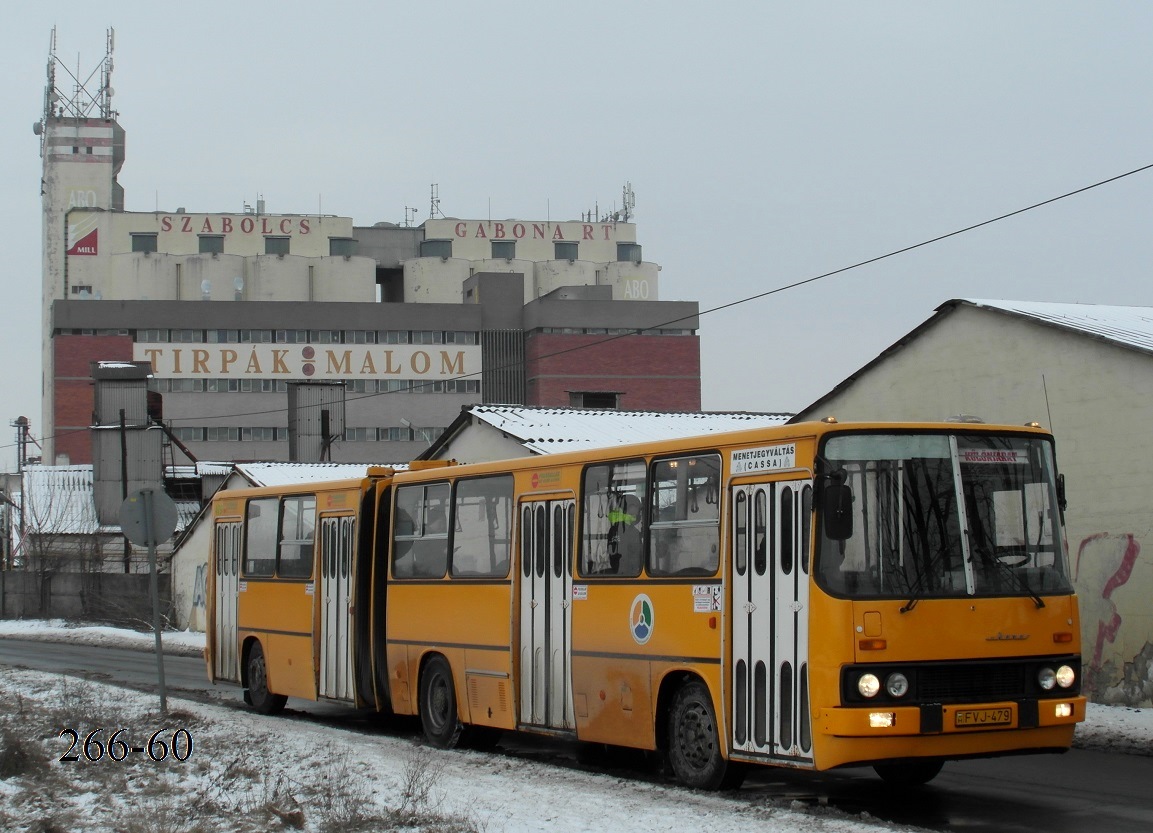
{"left": 729, "top": 480, "right": 813, "bottom": 764}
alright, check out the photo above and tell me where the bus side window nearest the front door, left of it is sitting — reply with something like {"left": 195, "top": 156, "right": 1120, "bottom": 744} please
{"left": 648, "top": 455, "right": 721, "bottom": 576}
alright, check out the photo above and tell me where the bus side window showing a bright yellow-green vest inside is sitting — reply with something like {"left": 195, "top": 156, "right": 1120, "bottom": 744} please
{"left": 581, "top": 460, "right": 645, "bottom": 576}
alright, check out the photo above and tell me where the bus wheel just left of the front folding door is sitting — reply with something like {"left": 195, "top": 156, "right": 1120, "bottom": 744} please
{"left": 669, "top": 681, "right": 745, "bottom": 789}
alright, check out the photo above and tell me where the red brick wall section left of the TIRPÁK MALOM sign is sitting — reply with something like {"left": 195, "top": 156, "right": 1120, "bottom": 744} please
{"left": 53, "top": 336, "right": 133, "bottom": 463}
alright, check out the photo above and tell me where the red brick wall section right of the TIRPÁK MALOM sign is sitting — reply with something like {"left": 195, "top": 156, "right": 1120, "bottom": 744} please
{"left": 525, "top": 333, "right": 701, "bottom": 411}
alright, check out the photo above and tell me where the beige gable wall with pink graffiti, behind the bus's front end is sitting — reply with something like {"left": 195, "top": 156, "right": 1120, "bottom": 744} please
{"left": 797, "top": 297, "right": 1153, "bottom": 705}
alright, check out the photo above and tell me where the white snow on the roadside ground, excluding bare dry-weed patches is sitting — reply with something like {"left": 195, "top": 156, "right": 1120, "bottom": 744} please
{"left": 0, "top": 621, "right": 1153, "bottom": 833}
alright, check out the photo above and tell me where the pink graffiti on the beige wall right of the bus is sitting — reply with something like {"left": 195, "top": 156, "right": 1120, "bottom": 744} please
{"left": 1075, "top": 532, "right": 1150, "bottom": 705}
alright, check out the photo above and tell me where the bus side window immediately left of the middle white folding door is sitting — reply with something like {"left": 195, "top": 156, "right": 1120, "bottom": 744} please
{"left": 452, "top": 475, "right": 512, "bottom": 577}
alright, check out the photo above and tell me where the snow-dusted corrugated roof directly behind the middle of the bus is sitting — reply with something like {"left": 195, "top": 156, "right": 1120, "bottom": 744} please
{"left": 468, "top": 405, "right": 791, "bottom": 455}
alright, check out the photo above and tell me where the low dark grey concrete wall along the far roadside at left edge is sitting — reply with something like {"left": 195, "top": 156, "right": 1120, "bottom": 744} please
{"left": 0, "top": 570, "right": 173, "bottom": 626}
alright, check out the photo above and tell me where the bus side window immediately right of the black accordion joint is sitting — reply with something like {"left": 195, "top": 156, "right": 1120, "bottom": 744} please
{"left": 392, "top": 483, "right": 449, "bottom": 578}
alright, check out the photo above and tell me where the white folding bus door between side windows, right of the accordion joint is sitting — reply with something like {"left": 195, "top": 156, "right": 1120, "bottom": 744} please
{"left": 519, "top": 500, "right": 575, "bottom": 729}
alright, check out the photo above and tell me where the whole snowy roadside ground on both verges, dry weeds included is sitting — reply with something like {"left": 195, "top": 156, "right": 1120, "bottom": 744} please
{"left": 0, "top": 621, "right": 1153, "bottom": 833}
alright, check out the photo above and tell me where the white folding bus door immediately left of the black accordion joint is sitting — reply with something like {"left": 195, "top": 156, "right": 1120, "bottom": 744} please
{"left": 318, "top": 515, "right": 356, "bottom": 700}
